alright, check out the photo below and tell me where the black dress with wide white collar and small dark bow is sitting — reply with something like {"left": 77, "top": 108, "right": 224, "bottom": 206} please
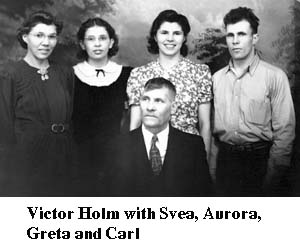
{"left": 73, "top": 62, "right": 132, "bottom": 196}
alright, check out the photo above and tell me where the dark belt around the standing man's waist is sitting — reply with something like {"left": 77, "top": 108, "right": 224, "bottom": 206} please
{"left": 220, "top": 141, "right": 271, "bottom": 152}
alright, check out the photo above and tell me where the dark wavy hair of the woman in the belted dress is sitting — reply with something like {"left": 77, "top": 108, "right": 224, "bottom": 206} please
{"left": 17, "top": 10, "right": 63, "bottom": 49}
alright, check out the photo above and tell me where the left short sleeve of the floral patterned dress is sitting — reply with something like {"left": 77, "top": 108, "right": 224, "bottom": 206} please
{"left": 126, "top": 68, "right": 143, "bottom": 105}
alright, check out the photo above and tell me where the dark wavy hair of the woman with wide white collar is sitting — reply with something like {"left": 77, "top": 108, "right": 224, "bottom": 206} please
{"left": 77, "top": 17, "right": 119, "bottom": 60}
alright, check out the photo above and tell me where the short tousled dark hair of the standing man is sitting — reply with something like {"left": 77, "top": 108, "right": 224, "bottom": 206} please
{"left": 223, "top": 7, "right": 259, "bottom": 34}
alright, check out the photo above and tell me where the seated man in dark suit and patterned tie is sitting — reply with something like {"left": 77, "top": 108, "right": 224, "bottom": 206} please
{"left": 106, "top": 78, "right": 212, "bottom": 196}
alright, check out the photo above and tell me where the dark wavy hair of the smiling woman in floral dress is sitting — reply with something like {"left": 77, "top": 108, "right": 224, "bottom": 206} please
{"left": 147, "top": 9, "right": 191, "bottom": 57}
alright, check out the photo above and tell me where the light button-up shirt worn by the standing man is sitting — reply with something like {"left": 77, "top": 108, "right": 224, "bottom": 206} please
{"left": 213, "top": 55, "right": 295, "bottom": 165}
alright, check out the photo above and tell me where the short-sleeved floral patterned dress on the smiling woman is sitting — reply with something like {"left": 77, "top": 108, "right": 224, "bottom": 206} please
{"left": 127, "top": 58, "right": 212, "bottom": 135}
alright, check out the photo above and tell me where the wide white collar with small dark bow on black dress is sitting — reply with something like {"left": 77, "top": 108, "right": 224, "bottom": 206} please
{"left": 73, "top": 60, "right": 122, "bottom": 87}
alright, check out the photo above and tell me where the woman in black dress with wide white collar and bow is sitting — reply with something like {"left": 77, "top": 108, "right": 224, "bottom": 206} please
{"left": 73, "top": 18, "right": 131, "bottom": 196}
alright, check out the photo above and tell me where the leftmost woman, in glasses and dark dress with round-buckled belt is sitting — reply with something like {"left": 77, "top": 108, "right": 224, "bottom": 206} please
{"left": 0, "top": 11, "right": 73, "bottom": 196}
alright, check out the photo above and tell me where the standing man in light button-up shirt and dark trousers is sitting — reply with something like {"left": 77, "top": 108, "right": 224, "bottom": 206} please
{"left": 213, "top": 7, "right": 295, "bottom": 196}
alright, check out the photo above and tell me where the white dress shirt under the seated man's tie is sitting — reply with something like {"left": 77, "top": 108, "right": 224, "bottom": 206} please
{"left": 142, "top": 125, "right": 170, "bottom": 163}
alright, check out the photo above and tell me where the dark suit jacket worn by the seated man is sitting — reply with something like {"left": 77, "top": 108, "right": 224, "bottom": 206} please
{"left": 106, "top": 126, "right": 212, "bottom": 196}
